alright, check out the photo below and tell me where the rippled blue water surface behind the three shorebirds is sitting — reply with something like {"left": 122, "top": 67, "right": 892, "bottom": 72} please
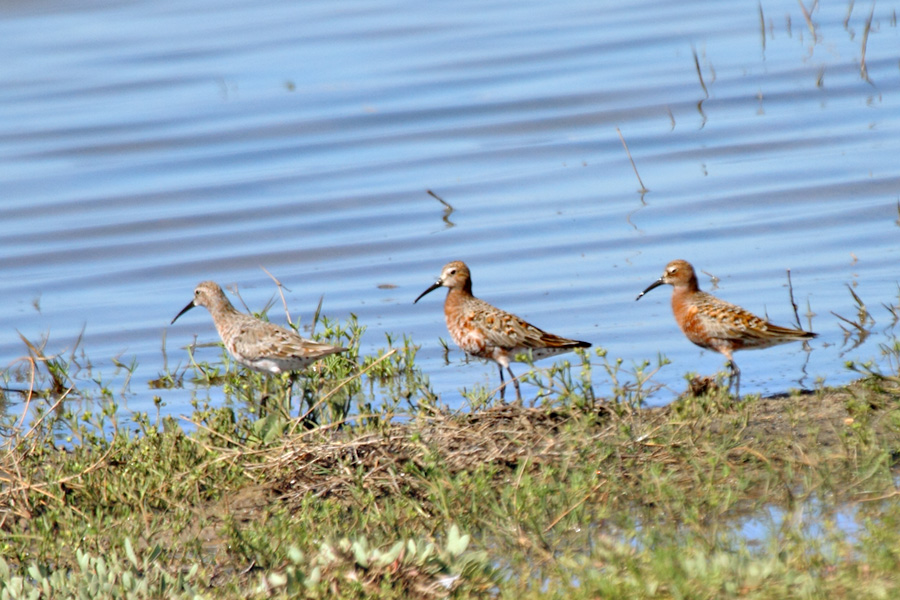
{"left": 0, "top": 0, "right": 900, "bottom": 414}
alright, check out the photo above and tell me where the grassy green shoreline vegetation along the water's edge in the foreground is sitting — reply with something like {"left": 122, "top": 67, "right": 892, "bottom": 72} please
{"left": 0, "top": 319, "right": 900, "bottom": 599}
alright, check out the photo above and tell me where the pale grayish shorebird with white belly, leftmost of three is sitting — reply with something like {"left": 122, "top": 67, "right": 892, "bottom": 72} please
{"left": 172, "top": 281, "right": 347, "bottom": 404}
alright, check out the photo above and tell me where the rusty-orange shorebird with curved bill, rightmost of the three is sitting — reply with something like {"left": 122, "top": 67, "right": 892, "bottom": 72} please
{"left": 635, "top": 260, "right": 816, "bottom": 398}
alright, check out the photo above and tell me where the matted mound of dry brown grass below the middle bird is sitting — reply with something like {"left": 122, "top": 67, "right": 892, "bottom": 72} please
{"left": 272, "top": 404, "right": 604, "bottom": 506}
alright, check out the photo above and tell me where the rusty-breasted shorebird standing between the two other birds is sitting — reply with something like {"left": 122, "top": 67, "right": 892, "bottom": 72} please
{"left": 413, "top": 261, "right": 591, "bottom": 402}
